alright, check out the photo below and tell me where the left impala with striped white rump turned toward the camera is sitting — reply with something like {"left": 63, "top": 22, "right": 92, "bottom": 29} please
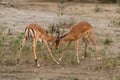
{"left": 17, "top": 24, "right": 59, "bottom": 67}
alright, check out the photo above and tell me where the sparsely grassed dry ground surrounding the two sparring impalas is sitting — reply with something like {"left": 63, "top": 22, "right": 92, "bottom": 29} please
{"left": 0, "top": 3, "right": 120, "bottom": 80}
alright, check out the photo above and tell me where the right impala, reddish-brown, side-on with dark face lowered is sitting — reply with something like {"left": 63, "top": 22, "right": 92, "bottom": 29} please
{"left": 56, "top": 22, "right": 100, "bottom": 63}
